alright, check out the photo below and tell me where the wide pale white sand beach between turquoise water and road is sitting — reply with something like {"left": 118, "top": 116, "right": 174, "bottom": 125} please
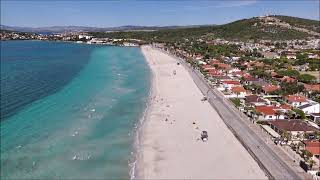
{"left": 137, "top": 46, "right": 267, "bottom": 179}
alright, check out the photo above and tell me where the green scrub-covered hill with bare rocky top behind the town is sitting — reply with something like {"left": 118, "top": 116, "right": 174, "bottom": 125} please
{"left": 91, "top": 16, "right": 320, "bottom": 42}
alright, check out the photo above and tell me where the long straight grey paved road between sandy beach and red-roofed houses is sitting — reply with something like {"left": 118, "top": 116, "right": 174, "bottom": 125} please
{"left": 156, "top": 47, "right": 310, "bottom": 180}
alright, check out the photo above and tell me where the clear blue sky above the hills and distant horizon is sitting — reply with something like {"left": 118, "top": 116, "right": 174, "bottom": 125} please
{"left": 0, "top": 0, "right": 320, "bottom": 27}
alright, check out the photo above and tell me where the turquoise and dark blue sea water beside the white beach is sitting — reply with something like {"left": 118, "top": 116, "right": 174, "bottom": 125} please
{"left": 0, "top": 41, "right": 150, "bottom": 179}
